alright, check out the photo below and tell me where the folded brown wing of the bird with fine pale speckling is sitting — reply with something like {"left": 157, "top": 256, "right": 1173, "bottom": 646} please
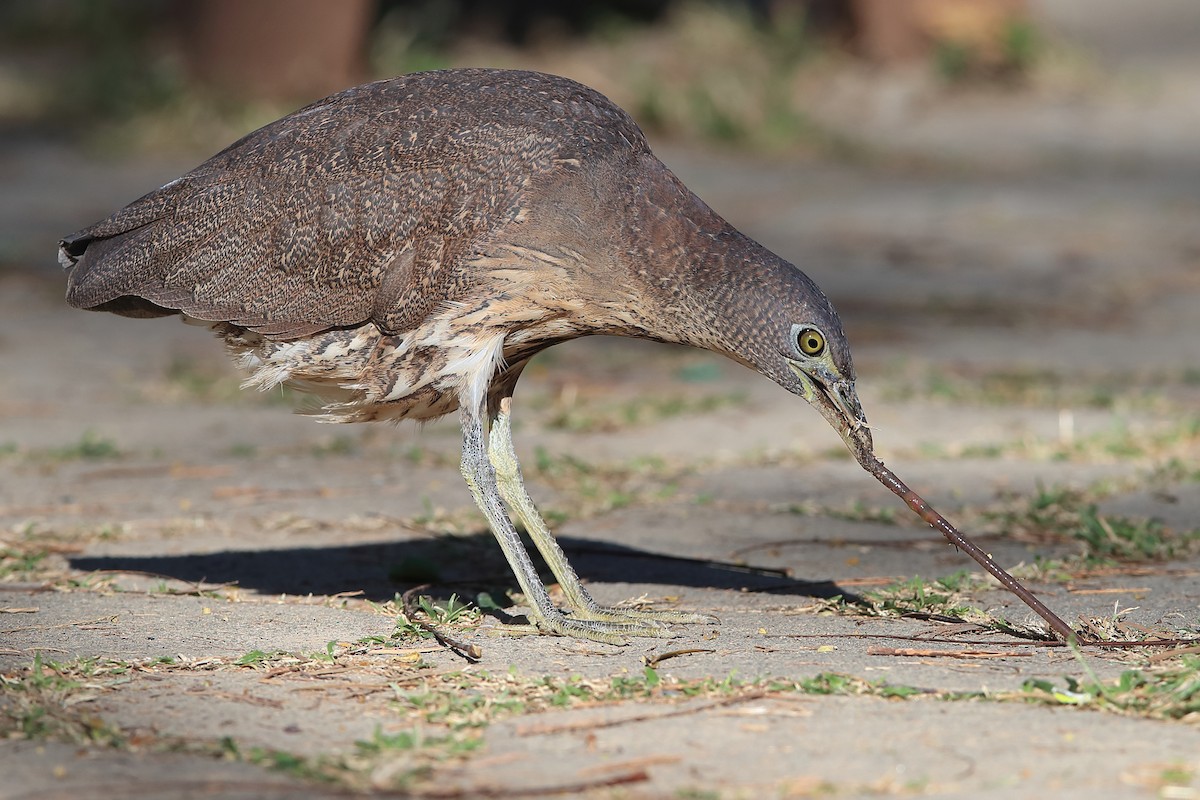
{"left": 61, "top": 92, "right": 553, "bottom": 338}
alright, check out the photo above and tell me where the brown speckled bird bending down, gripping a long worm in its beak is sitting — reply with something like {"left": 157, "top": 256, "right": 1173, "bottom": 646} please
{"left": 59, "top": 68, "right": 871, "bottom": 644}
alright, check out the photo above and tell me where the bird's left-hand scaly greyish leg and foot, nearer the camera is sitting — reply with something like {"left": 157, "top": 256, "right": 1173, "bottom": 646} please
{"left": 453, "top": 403, "right": 647, "bottom": 644}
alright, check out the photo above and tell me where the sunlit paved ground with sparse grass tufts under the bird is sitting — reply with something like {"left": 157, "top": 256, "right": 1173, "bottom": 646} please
{"left": 0, "top": 17, "right": 1200, "bottom": 798}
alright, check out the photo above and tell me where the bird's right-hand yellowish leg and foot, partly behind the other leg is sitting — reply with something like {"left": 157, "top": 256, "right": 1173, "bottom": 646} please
{"left": 487, "top": 397, "right": 713, "bottom": 634}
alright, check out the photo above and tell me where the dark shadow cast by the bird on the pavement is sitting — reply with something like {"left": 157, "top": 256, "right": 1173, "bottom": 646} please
{"left": 70, "top": 533, "right": 862, "bottom": 603}
